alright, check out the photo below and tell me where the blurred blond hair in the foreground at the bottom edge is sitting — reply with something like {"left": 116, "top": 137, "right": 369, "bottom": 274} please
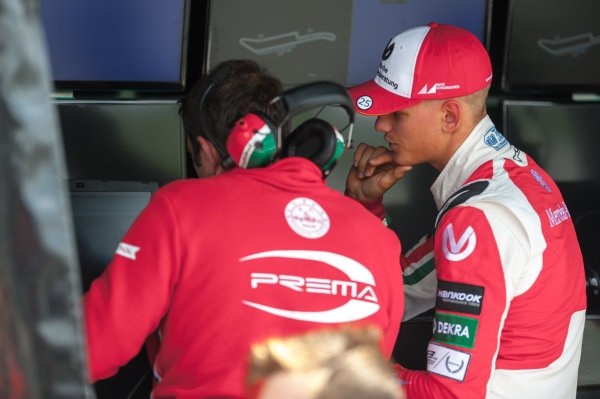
{"left": 246, "top": 326, "right": 405, "bottom": 399}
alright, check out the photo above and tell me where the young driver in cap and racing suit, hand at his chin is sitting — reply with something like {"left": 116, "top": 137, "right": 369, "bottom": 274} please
{"left": 347, "top": 23, "right": 586, "bottom": 399}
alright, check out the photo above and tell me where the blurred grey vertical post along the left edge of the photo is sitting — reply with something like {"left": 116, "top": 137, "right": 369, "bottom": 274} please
{"left": 0, "top": 0, "right": 93, "bottom": 399}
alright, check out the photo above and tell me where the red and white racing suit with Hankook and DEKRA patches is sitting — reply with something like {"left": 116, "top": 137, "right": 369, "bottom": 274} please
{"left": 371, "top": 116, "right": 586, "bottom": 399}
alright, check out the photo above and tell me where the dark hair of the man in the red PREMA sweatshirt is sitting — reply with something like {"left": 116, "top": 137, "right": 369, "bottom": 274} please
{"left": 179, "top": 60, "right": 284, "bottom": 165}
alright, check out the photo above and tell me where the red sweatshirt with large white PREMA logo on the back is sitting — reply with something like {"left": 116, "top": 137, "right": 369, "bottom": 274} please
{"left": 84, "top": 157, "right": 403, "bottom": 399}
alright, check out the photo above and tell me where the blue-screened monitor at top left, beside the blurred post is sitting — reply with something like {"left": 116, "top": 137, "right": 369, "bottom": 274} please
{"left": 39, "top": 0, "right": 189, "bottom": 91}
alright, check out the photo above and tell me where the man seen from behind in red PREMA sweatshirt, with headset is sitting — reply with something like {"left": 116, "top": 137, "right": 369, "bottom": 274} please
{"left": 84, "top": 60, "right": 403, "bottom": 399}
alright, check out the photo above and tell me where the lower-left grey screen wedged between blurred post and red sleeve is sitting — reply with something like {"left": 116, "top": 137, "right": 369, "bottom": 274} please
{"left": 69, "top": 179, "right": 158, "bottom": 291}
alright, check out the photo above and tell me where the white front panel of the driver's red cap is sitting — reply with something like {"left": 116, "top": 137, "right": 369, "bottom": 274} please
{"left": 374, "top": 26, "right": 430, "bottom": 98}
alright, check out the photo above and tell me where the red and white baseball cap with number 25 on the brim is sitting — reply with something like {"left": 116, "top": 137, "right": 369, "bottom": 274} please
{"left": 349, "top": 22, "right": 492, "bottom": 115}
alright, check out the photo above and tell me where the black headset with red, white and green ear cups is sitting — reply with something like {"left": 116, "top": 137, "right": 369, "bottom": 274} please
{"left": 199, "top": 65, "right": 354, "bottom": 177}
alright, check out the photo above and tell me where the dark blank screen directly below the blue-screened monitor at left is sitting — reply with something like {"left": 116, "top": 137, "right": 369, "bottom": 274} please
{"left": 54, "top": 100, "right": 187, "bottom": 186}
